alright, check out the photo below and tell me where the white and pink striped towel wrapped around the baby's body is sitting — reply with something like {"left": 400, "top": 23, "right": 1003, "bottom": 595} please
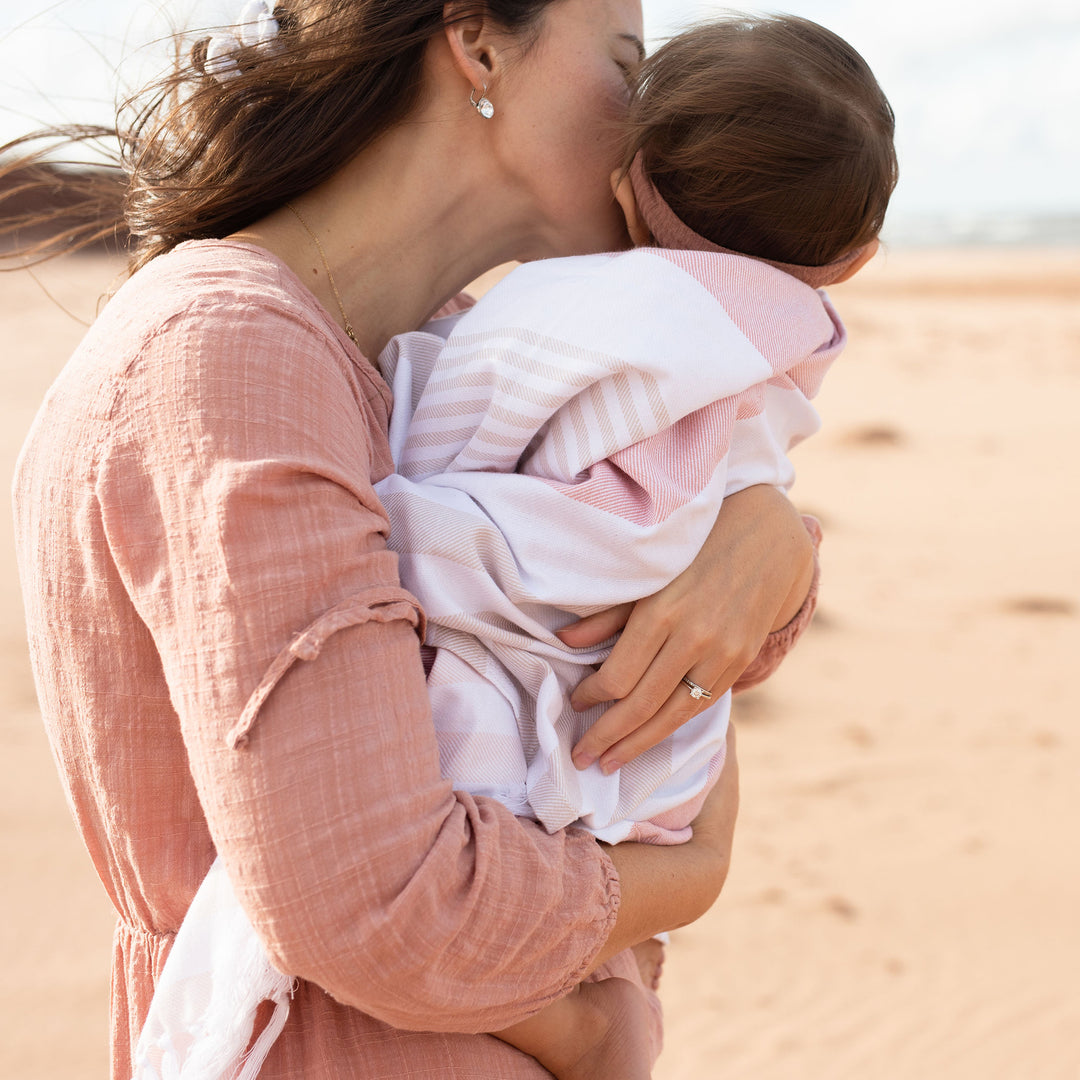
{"left": 378, "top": 248, "right": 845, "bottom": 842}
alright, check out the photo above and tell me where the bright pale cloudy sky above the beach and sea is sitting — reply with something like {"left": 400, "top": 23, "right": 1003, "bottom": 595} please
{"left": 0, "top": 0, "right": 1080, "bottom": 232}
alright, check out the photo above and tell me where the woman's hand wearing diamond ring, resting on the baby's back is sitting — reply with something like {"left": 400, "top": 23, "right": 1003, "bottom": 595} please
{"left": 558, "top": 486, "right": 813, "bottom": 772}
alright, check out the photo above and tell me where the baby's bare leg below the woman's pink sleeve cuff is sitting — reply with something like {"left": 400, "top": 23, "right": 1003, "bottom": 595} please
{"left": 494, "top": 978, "right": 651, "bottom": 1080}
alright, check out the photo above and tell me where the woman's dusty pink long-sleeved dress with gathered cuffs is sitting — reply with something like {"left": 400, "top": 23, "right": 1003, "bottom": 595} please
{"left": 14, "top": 241, "right": 812, "bottom": 1080}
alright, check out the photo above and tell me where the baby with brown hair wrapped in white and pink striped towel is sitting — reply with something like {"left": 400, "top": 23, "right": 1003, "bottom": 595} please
{"left": 136, "top": 16, "right": 896, "bottom": 1080}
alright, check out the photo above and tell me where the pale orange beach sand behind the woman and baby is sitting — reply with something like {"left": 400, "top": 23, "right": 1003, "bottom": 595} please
{"left": 0, "top": 251, "right": 1080, "bottom": 1080}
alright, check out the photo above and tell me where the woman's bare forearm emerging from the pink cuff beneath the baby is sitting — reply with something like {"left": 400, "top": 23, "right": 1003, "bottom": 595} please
{"left": 591, "top": 725, "right": 739, "bottom": 970}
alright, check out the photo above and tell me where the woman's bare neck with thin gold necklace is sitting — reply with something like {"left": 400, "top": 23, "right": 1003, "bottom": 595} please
{"left": 234, "top": 110, "right": 534, "bottom": 361}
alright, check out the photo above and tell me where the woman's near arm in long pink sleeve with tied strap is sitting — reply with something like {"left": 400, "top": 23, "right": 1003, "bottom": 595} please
{"left": 98, "top": 301, "right": 726, "bottom": 1031}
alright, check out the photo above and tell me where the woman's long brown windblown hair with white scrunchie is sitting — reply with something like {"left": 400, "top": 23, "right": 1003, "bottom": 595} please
{"left": 0, "top": 0, "right": 552, "bottom": 271}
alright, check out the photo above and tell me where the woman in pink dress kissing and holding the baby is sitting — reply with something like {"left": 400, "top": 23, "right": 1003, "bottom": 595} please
{"left": 15, "top": 0, "right": 812, "bottom": 1078}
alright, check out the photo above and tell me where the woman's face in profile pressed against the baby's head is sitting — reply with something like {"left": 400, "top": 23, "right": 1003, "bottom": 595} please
{"left": 491, "top": 0, "right": 644, "bottom": 258}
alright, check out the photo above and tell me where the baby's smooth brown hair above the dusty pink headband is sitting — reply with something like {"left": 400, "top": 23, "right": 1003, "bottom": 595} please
{"left": 626, "top": 15, "right": 897, "bottom": 266}
